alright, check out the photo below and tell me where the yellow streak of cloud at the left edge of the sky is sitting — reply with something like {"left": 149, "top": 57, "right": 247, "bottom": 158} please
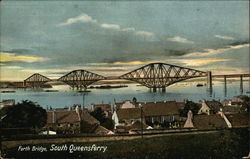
{"left": 0, "top": 52, "right": 49, "bottom": 63}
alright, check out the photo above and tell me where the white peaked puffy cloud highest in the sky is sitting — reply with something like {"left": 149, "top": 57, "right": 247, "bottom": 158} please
{"left": 59, "top": 13, "right": 97, "bottom": 26}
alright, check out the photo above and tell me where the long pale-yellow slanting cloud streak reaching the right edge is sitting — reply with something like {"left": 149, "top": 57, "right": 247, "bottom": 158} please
{"left": 183, "top": 44, "right": 249, "bottom": 57}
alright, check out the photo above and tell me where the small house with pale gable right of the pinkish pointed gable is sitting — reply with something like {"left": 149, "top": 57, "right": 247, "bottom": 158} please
{"left": 198, "top": 101, "right": 223, "bottom": 115}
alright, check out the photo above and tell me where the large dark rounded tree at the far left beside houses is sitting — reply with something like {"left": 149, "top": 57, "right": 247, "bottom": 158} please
{"left": 1, "top": 100, "right": 47, "bottom": 128}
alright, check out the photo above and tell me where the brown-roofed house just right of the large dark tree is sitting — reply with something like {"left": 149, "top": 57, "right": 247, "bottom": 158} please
{"left": 45, "top": 106, "right": 110, "bottom": 134}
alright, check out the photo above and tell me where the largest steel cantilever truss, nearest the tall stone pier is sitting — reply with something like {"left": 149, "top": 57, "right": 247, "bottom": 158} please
{"left": 119, "top": 63, "right": 207, "bottom": 88}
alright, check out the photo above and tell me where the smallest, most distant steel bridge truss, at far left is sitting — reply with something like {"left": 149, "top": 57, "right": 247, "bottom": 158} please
{"left": 24, "top": 73, "right": 51, "bottom": 87}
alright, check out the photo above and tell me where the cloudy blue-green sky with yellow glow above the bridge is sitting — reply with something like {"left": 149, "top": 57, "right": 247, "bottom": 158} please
{"left": 0, "top": 0, "right": 249, "bottom": 81}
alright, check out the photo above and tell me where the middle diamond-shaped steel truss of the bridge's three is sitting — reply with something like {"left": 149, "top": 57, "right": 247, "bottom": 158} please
{"left": 58, "top": 70, "right": 106, "bottom": 89}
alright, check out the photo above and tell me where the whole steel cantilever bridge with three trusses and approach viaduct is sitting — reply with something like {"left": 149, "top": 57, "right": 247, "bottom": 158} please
{"left": 24, "top": 63, "right": 249, "bottom": 90}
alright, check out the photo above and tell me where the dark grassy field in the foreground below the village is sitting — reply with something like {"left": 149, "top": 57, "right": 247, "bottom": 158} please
{"left": 4, "top": 128, "right": 250, "bottom": 159}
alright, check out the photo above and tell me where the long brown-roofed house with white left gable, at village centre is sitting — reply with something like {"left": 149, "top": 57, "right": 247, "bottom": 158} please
{"left": 112, "top": 101, "right": 185, "bottom": 127}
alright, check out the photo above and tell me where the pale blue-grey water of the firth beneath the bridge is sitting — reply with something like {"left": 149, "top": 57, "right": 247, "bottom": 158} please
{"left": 0, "top": 81, "right": 249, "bottom": 108}
